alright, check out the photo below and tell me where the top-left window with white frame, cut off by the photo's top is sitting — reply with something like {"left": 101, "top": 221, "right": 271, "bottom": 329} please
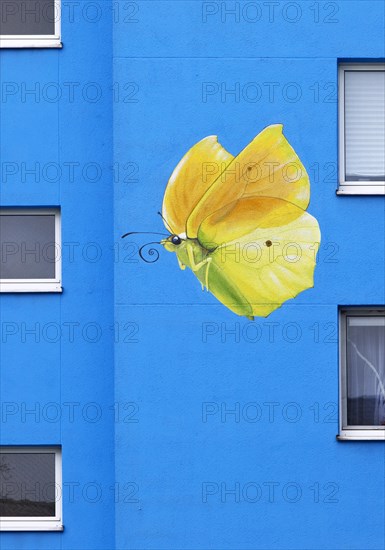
{"left": 0, "top": 0, "right": 61, "bottom": 48}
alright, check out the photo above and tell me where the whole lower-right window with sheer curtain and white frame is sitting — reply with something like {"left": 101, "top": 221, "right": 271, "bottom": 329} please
{"left": 338, "top": 307, "right": 385, "bottom": 439}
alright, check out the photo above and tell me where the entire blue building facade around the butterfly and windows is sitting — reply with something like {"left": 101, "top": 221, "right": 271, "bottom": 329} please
{"left": 0, "top": 0, "right": 385, "bottom": 550}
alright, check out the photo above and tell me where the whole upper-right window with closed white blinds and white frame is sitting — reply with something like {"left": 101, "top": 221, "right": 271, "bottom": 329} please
{"left": 337, "top": 63, "right": 385, "bottom": 195}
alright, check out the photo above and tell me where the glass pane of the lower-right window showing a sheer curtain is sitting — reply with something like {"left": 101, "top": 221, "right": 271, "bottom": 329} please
{"left": 346, "top": 316, "right": 385, "bottom": 426}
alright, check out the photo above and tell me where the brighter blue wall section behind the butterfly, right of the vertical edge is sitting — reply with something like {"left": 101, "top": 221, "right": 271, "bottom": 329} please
{"left": 114, "top": 1, "right": 384, "bottom": 550}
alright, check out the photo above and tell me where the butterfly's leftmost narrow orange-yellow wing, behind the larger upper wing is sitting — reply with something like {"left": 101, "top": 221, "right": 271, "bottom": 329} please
{"left": 162, "top": 136, "right": 234, "bottom": 235}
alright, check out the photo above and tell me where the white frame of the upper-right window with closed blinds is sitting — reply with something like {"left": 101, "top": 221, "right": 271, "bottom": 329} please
{"left": 337, "top": 62, "right": 385, "bottom": 195}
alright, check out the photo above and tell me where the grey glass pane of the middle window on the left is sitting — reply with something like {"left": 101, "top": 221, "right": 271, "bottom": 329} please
{"left": 0, "top": 214, "right": 56, "bottom": 279}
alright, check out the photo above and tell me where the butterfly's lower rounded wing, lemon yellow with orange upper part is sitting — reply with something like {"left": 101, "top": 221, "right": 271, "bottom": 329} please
{"left": 198, "top": 197, "right": 320, "bottom": 317}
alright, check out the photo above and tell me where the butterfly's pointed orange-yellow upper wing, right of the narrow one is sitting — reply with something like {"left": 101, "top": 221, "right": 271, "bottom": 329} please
{"left": 187, "top": 124, "right": 310, "bottom": 238}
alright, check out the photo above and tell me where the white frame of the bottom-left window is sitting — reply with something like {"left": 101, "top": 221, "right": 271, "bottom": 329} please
{"left": 0, "top": 445, "right": 63, "bottom": 531}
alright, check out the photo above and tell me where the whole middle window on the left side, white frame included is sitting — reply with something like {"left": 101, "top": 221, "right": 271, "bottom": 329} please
{"left": 0, "top": 208, "right": 62, "bottom": 292}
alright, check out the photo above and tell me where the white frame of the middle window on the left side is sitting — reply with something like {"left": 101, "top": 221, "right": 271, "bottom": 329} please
{"left": 0, "top": 207, "right": 63, "bottom": 293}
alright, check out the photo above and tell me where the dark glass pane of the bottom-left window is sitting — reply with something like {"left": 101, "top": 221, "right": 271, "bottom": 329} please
{"left": 0, "top": 452, "right": 56, "bottom": 517}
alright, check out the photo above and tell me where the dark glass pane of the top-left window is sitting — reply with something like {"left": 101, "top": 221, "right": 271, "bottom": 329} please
{"left": 0, "top": 0, "right": 55, "bottom": 36}
